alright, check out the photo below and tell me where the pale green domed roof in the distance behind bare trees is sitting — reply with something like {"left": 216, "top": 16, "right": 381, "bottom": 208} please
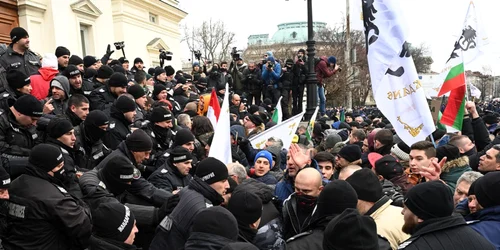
{"left": 271, "top": 22, "right": 326, "bottom": 43}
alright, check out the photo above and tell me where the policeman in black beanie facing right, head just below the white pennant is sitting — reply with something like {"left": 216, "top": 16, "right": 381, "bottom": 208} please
{"left": 149, "top": 157, "right": 229, "bottom": 250}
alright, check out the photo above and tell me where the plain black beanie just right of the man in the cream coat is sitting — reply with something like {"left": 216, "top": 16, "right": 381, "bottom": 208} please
{"left": 404, "top": 181, "right": 456, "bottom": 220}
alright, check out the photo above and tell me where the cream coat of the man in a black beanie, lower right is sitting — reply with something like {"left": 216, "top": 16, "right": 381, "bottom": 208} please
{"left": 365, "top": 196, "right": 409, "bottom": 249}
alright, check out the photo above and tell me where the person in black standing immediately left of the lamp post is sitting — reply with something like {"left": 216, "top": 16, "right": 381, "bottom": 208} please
{"left": 292, "top": 49, "right": 309, "bottom": 115}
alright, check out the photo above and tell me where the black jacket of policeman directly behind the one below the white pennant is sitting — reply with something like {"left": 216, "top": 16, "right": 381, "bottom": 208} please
{"left": 148, "top": 160, "right": 193, "bottom": 193}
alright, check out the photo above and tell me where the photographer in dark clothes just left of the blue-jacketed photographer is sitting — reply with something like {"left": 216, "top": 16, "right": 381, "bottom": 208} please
{"left": 243, "top": 62, "right": 262, "bottom": 105}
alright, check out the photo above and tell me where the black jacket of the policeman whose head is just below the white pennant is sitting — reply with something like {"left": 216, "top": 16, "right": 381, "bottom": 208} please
{"left": 149, "top": 176, "right": 224, "bottom": 250}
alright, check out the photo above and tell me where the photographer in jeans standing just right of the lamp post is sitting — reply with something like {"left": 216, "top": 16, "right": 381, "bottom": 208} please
{"left": 314, "top": 56, "right": 341, "bottom": 116}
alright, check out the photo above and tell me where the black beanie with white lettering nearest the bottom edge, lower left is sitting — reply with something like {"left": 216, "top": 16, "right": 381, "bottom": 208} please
{"left": 92, "top": 202, "right": 135, "bottom": 242}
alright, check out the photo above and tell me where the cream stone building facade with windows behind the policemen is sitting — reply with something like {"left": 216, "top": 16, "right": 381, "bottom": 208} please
{"left": 0, "top": 0, "right": 187, "bottom": 68}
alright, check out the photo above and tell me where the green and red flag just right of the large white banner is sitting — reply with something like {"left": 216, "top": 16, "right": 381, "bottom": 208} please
{"left": 438, "top": 60, "right": 466, "bottom": 130}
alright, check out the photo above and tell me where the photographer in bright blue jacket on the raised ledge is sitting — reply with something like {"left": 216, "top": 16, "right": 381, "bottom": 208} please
{"left": 262, "top": 56, "right": 281, "bottom": 104}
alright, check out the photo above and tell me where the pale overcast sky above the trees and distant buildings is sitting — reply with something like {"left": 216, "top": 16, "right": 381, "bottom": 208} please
{"left": 180, "top": 0, "right": 500, "bottom": 75}
